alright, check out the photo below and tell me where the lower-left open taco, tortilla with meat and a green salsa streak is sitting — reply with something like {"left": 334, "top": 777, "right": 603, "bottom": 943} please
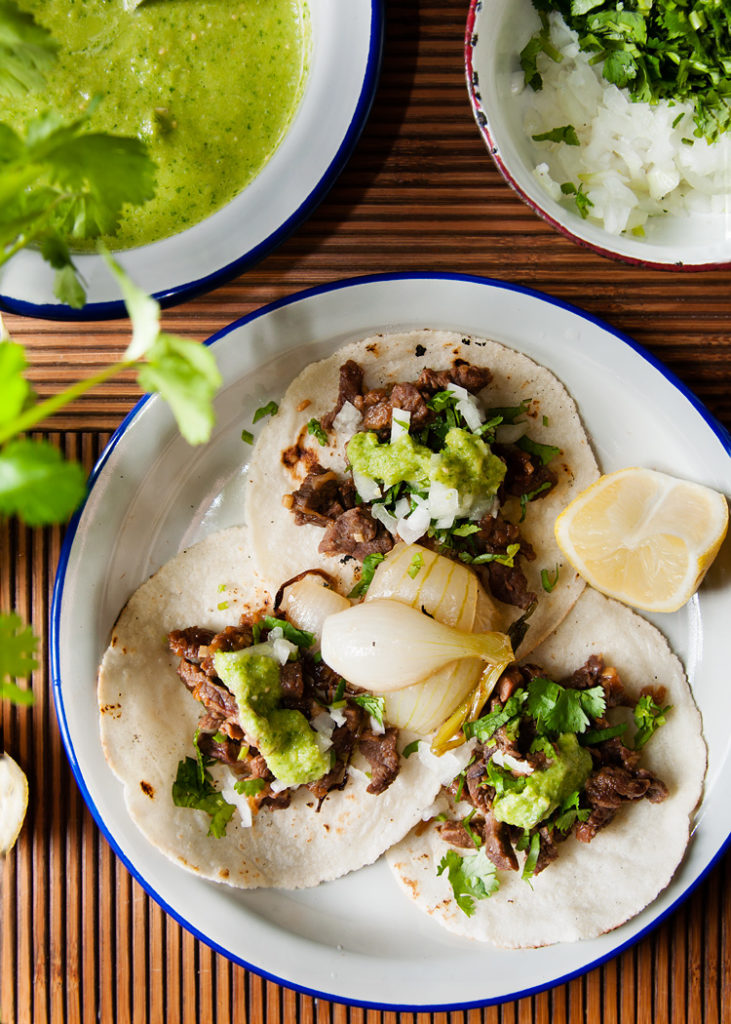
{"left": 98, "top": 527, "right": 473, "bottom": 888}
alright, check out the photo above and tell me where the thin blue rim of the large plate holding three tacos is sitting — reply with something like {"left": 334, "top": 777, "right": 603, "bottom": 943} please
{"left": 50, "top": 271, "right": 731, "bottom": 1013}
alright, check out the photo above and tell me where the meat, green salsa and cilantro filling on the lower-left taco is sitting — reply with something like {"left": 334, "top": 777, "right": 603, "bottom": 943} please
{"left": 168, "top": 609, "right": 399, "bottom": 831}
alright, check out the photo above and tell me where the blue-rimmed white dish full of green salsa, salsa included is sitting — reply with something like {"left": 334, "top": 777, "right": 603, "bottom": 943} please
{"left": 0, "top": 0, "right": 383, "bottom": 319}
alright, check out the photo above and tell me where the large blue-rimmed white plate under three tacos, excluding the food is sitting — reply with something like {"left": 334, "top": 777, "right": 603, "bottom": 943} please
{"left": 51, "top": 274, "right": 731, "bottom": 1011}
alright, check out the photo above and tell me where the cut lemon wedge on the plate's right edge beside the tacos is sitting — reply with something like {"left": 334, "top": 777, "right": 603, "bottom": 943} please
{"left": 556, "top": 468, "right": 729, "bottom": 611}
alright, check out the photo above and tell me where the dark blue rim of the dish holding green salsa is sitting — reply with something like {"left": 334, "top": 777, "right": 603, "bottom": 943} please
{"left": 0, "top": 0, "right": 385, "bottom": 322}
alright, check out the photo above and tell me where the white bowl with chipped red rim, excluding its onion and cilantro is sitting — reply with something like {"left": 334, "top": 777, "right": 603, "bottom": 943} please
{"left": 465, "top": 0, "right": 731, "bottom": 270}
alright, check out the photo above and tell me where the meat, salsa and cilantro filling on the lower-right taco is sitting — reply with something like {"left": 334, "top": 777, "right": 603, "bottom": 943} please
{"left": 437, "top": 654, "right": 671, "bottom": 915}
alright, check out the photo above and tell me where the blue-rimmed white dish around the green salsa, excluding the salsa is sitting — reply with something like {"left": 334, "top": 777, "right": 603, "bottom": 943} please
{"left": 0, "top": 0, "right": 384, "bottom": 319}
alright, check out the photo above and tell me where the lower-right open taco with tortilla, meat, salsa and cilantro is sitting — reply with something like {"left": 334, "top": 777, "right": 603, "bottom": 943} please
{"left": 387, "top": 590, "right": 706, "bottom": 948}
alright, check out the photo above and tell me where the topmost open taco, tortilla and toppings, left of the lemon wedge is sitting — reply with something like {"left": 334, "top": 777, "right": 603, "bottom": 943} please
{"left": 246, "top": 330, "right": 598, "bottom": 653}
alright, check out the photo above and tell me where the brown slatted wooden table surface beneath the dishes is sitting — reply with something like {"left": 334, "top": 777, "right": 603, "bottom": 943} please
{"left": 0, "top": 0, "right": 731, "bottom": 1024}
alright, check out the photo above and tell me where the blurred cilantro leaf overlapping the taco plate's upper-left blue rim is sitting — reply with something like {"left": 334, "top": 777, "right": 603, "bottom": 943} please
{"left": 137, "top": 334, "right": 221, "bottom": 444}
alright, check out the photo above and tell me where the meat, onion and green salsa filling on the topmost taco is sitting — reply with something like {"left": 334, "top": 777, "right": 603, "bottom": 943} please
{"left": 285, "top": 358, "right": 560, "bottom": 609}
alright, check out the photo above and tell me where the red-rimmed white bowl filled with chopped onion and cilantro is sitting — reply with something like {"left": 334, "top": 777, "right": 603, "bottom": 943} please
{"left": 465, "top": 0, "right": 731, "bottom": 269}
